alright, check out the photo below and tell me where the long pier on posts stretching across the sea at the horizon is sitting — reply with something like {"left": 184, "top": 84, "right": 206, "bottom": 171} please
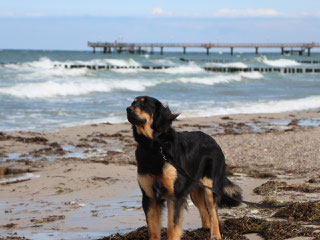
{"left": 88, "top": 42, "right": 320, "bottom": 56}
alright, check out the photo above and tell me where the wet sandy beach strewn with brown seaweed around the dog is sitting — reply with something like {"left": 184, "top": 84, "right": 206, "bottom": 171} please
{"left": 0, "top": 111, "right": 320, "bottom": 240}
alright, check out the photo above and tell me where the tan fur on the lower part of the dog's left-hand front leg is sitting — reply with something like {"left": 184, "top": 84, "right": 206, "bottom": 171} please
{"left": 147, "top": 202, "right": 162, "bottom": 240}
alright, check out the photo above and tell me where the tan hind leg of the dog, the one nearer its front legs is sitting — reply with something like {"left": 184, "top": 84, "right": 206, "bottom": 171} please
{"left": 190, "top": 187, "right": 210, "bottom": 228}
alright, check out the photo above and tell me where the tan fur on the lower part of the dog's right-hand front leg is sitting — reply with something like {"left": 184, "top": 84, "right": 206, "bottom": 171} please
{"left": 167, "top": 200, "right": 184, "bottom": 240}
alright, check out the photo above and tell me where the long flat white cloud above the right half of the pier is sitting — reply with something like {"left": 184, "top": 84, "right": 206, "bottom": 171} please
{"left": 212, "top": 8, "right": 282, "bottom": 17}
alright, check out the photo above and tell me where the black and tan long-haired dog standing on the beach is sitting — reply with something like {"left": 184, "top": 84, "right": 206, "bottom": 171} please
{"left": 126, "top": 96, "right": 242, "bottom": 240}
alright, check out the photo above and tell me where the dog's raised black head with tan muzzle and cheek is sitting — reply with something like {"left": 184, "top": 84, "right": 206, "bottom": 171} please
{"left": 127, "top": 96, "right": 179, "bottom": 139}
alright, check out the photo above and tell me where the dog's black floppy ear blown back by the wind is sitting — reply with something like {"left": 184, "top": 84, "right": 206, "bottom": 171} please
{"left": 153, "top": 102, "right": 179, "bottom": 133}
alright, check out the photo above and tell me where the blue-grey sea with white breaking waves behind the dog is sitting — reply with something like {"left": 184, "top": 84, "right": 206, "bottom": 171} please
{"left": 0, "top": 50, "right": 320, "bottom": 131}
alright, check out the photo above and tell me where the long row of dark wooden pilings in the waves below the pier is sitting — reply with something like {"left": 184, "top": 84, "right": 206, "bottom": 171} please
{"left": 54, "top": 64, "right": 320, "bottom": 73}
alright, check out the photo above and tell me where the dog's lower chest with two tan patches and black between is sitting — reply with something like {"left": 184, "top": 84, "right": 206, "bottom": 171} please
{"left": 138, "top": 163, "right": 177, "bottom": 199}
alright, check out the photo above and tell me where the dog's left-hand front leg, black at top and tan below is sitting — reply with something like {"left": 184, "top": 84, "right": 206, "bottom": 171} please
{"left": 142, "top": 193, "right": 162, "bottom": 240}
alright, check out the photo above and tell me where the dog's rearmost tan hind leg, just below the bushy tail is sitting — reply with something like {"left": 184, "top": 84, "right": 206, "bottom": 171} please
{"left": 202, "top": 177, "right": 221, "bottom": 240}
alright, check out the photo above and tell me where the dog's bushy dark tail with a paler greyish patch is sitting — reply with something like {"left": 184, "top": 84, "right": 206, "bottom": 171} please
{"left": 217, "top": 176, "right": 242, "bottom": 208}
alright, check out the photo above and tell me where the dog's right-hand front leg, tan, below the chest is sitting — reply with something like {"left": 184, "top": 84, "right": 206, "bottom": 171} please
{"left": 167, "top": 199, "right": 185, "bottom": 240}
